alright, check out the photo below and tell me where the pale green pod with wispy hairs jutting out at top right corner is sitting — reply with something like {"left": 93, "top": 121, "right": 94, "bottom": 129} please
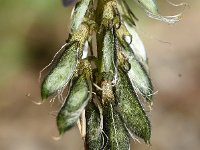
{"left": 135, "top": 0, "right": 181, "bottom": 24}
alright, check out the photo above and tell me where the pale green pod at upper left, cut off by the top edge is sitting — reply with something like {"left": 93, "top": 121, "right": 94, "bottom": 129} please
{"left": 71, "top": 0, "right": 91, "bottom": 32}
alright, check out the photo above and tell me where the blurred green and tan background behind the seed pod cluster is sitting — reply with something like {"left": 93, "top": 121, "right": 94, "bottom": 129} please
{"left": 0, "top": 0, "right": 200, "bottom": 150}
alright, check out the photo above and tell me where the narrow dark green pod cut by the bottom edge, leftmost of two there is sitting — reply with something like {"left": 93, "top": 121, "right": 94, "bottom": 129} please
{"left": 85, "top": 102, "right": 103, "bottom": 150}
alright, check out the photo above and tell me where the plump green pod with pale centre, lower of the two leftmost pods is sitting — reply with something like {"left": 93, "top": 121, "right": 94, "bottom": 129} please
{"left": 57, "top": 74, "right": 92, "bottom": 135}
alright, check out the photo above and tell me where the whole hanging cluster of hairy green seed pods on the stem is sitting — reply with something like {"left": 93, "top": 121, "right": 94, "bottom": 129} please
{"left": 41, "top": 0, "right": 183, "bottom": 150}
